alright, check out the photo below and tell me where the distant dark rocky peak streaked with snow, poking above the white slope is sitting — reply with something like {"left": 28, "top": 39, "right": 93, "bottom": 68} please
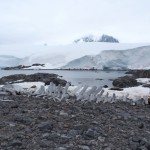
{"left": 74, "top": 34, "right": 119, "bottom": 43}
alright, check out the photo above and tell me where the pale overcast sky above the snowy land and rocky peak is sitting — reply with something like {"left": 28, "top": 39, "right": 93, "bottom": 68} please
{"left": 0, "top": 0, "right": 150, "bottom": 56}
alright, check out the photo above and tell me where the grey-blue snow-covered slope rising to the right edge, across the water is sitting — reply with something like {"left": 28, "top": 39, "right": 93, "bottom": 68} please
{"left": 62, "top": 46, "right": 150, "bottom": 69}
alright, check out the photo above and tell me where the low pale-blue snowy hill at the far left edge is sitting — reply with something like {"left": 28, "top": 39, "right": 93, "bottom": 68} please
{"left": 0, "top": 55, "right": 21, "bottom": 67}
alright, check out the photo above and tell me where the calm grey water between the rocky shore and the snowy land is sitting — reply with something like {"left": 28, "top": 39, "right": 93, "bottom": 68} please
{"left": 0, "top": 70, "right": 125, "bottom": 87}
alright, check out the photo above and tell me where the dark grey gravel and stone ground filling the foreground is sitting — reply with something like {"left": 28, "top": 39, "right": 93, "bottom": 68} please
{"left": 0, "top": 96, "right": 150, "bottom": 150}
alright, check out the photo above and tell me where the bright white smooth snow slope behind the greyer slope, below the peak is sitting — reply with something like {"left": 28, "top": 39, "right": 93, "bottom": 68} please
{"left": 21, "top": 42, "right": 150, "bottom": 69}
